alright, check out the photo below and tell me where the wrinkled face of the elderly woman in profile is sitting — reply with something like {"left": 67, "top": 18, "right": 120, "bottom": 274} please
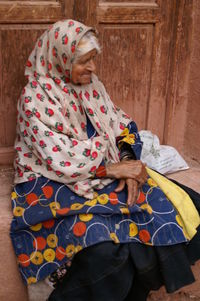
{"left": 71, "top": 49, "right": 97, "bottom": 85}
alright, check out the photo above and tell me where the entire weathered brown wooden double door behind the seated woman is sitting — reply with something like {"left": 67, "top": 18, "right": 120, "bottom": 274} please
{"left": 0, "top": 0, "right": 197, "bottom": 165}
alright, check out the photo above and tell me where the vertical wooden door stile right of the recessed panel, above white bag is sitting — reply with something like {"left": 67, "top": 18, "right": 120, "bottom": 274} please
{"left": 147, "top": 0, "right": 176, "bottom": 143}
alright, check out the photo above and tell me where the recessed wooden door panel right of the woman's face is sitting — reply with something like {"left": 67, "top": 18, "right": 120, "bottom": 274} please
{"left": 99, "top": 25, "right": 153, "bottom": 129}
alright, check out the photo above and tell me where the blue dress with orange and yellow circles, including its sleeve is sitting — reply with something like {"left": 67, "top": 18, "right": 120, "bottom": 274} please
{"left": 11, "top": 121, "right": 187, "bottom": 284}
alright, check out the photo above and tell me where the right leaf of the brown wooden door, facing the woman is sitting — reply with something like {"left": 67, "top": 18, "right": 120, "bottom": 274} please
{"left": 74, "top": 0, "right": 177, "bottom": 142}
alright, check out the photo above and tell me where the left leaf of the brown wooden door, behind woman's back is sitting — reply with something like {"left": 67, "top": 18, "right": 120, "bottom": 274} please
{"left": 0, "top": 0, "right": 73, "bottom": 165}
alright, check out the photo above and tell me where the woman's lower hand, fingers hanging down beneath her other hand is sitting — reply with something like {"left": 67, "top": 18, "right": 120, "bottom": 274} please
{"left": 115, "top": 179, "right": 139, "bottom": 206}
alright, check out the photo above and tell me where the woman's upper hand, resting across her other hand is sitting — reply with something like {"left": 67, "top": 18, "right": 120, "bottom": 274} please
{"left": 106, "top": 160, "right": 147, "bottom": 185}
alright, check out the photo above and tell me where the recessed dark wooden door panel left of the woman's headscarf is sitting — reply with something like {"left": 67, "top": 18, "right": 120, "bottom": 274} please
{"left": 0, "top": 25, "right": 47, "bottom": 147}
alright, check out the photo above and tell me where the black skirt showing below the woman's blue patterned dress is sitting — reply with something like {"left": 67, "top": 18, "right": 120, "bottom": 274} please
{"left": 48, "top": 181, "right": 200, "bottom": 301}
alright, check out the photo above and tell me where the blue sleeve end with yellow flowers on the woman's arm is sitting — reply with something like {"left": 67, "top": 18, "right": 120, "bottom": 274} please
{"left": 116, "top": 121, "right": 142, "bottom": 160}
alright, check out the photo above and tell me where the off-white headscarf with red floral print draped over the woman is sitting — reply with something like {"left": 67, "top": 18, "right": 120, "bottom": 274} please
{"left": 14, "top": 20, "right": 130, "bottom": 198}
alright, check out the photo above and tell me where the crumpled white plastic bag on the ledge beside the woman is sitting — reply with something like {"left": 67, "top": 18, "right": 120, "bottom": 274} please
{"left": 139, "top": 130, "right": 189, "bottom": 174}
